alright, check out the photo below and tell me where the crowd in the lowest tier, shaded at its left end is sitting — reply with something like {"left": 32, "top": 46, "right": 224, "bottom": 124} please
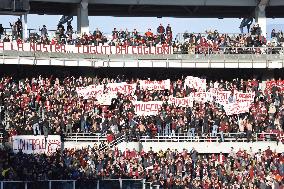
{"left": 0, "top": 145, "right": 284, "bottom": 189}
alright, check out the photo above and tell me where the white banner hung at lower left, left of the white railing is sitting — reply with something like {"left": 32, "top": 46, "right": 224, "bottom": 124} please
{"left": 12, "top": 135, "right": 61, "bottom": 154}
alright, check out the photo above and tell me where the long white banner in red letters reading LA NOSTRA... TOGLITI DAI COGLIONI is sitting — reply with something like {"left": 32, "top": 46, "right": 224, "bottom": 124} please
{"left": 0, "top": 42, "right": 173, "bottom": 55}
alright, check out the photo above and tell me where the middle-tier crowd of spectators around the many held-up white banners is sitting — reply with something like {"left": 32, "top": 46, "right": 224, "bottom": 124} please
{"left": 0, "top": 76, "right": 284, "bottom": 142}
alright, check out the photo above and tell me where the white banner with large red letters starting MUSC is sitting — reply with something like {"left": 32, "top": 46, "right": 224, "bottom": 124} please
{"left": 132, "top": 101, "right": 163, "bottom": 116}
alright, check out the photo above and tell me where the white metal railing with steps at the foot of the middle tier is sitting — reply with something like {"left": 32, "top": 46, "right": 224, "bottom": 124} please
{"left": 65, "top": 132, "right": 284, "bottom": 142}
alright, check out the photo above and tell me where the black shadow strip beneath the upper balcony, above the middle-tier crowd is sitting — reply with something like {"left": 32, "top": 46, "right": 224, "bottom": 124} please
{"left": 0, "top": 65, "right": 284, "bottom": 80}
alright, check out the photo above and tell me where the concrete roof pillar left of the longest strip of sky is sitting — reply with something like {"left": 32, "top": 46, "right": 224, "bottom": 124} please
{"left": 77, "top": 0, "right": 89, "bottom": 34}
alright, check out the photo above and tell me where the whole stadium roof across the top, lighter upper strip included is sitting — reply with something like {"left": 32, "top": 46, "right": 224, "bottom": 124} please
{"left": 3, "top": 0, "right": 284, "bottom": 18}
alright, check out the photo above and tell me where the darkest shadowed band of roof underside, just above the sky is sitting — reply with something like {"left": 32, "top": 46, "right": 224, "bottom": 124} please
{"left": 30, "top": 1, "right": 284, "bottom": 18}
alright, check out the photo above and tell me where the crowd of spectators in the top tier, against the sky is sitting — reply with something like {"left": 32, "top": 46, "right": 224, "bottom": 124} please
{"left": 2, "top": 20, "right": 284, "bottom": 54}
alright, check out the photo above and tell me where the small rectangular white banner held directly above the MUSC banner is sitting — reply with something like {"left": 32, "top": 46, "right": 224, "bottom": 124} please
{"left": 139, "top": 79, "right": 171, "bottom": 90}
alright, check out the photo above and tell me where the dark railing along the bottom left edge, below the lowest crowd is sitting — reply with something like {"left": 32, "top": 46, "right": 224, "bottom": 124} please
{"left": 0, "top": 179, "right": 153, "bottom": 189}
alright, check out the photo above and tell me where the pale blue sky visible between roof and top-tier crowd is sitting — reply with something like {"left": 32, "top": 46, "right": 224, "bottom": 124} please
{"left": 0, "top": 14, "right": 284, "bottom": 35}
